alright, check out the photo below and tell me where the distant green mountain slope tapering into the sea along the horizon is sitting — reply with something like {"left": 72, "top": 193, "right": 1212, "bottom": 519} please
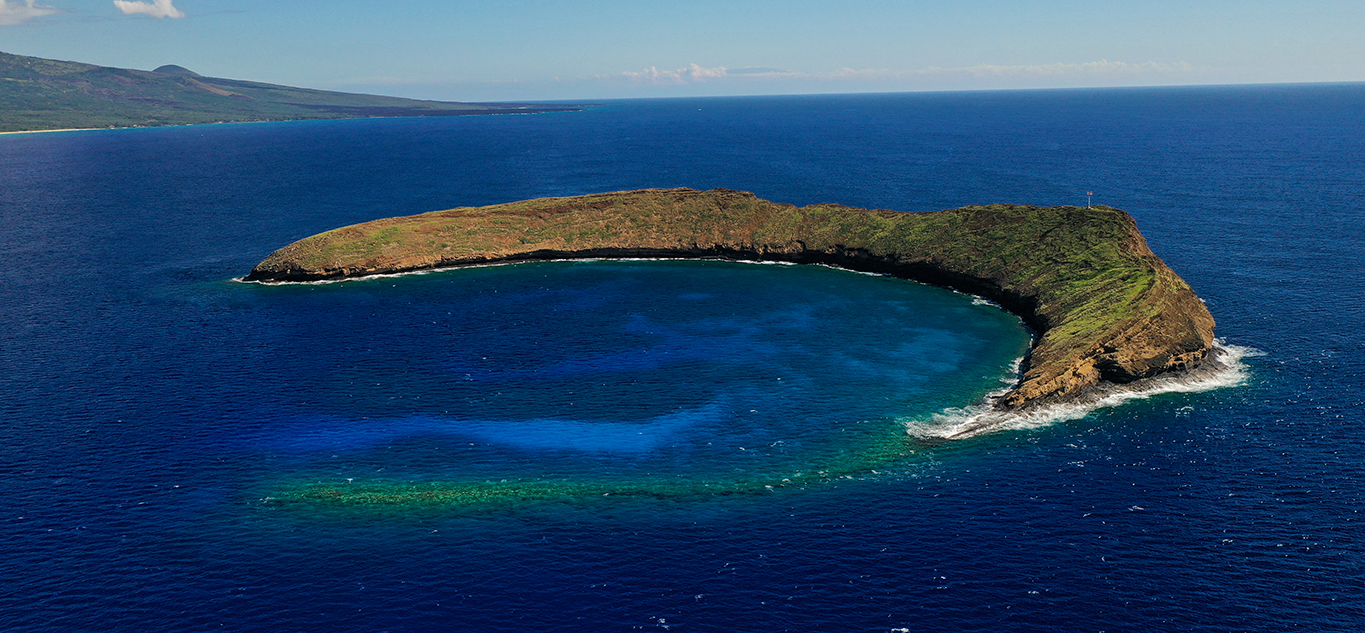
{"left": 0, "top": 53, "right": 579, "bottom": 132}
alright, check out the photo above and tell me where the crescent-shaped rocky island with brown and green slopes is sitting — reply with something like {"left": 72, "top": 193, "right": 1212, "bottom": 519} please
{"left": 247, "top": 188, "right": 1213, "bottom": 408}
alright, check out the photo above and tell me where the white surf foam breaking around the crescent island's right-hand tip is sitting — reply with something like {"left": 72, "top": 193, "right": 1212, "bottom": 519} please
{"left": 901, "top": 340, "right": 1264, "bottom": 439}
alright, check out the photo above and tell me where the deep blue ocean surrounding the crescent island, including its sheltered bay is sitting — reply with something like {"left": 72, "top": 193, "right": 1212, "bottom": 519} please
{"left": 0, "top": 85, "right": 1365, "bottom": 632}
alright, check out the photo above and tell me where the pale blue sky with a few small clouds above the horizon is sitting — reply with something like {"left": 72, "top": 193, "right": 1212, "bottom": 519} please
{"left": 0, "top": 0, "right": 1365, "bottom": 101}
